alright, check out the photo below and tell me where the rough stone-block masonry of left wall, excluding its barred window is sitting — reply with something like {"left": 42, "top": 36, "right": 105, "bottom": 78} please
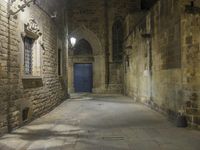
{"left": 0, "top": 0, "right": 67, "bottom": 134}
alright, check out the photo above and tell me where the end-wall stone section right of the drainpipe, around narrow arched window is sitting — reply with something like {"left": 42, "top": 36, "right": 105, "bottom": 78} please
{"left": 107, "top": 0, "right": 141, "bottom": 93}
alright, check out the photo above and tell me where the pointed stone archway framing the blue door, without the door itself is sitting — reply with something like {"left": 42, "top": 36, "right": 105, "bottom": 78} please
{"left": 68, "top": 26, "right": 105, "bottom": 93}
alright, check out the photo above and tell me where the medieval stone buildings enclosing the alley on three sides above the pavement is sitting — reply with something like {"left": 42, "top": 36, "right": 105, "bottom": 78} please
{"left": 0, "top": 0, "right": 200, "bottom": 149}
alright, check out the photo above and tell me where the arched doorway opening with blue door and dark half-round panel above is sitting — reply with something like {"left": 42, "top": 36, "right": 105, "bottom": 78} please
{"left": 73, "top": 39, "right": 93, "bottom": 93}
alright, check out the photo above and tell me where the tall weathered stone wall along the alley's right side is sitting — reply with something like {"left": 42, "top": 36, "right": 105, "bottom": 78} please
{"left": 124, "top": 1, "right": 200, "bottom": 125}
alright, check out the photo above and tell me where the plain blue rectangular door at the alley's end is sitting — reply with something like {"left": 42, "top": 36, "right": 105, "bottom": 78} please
{"left": 74, "top": 64, "right": 93, "bottom": 92}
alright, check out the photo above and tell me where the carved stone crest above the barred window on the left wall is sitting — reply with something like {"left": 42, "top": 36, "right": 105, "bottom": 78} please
{"left": 22, "top": 18, "right": 42, "bottom": 39}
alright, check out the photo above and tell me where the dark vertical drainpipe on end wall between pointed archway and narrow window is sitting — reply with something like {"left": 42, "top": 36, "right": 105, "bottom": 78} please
{"left": 104, "top": 0, "right": 110, "bottom": 88}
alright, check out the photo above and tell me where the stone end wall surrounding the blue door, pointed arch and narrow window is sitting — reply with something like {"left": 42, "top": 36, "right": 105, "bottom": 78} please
{"left": 68, "top": 0, "right": 140, "bottom": 93}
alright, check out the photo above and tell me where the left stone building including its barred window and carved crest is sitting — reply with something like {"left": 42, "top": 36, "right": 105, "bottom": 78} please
{"left": 0, "top": 0, "right": 67, "bottom": 133}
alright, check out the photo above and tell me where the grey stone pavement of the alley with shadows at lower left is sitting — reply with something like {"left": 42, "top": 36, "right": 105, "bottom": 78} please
{"left": 0, "top": 94, "right": 200, "bottom": 150}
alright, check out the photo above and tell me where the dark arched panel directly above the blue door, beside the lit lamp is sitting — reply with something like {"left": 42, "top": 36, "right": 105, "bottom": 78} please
{"left": 74, "top": 39, "right": 92, "bottom": 55}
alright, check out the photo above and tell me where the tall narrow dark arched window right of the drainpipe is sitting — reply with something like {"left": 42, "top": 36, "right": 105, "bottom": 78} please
{"left": 112, "top": 20, "right": 123, "bottom": 62}
